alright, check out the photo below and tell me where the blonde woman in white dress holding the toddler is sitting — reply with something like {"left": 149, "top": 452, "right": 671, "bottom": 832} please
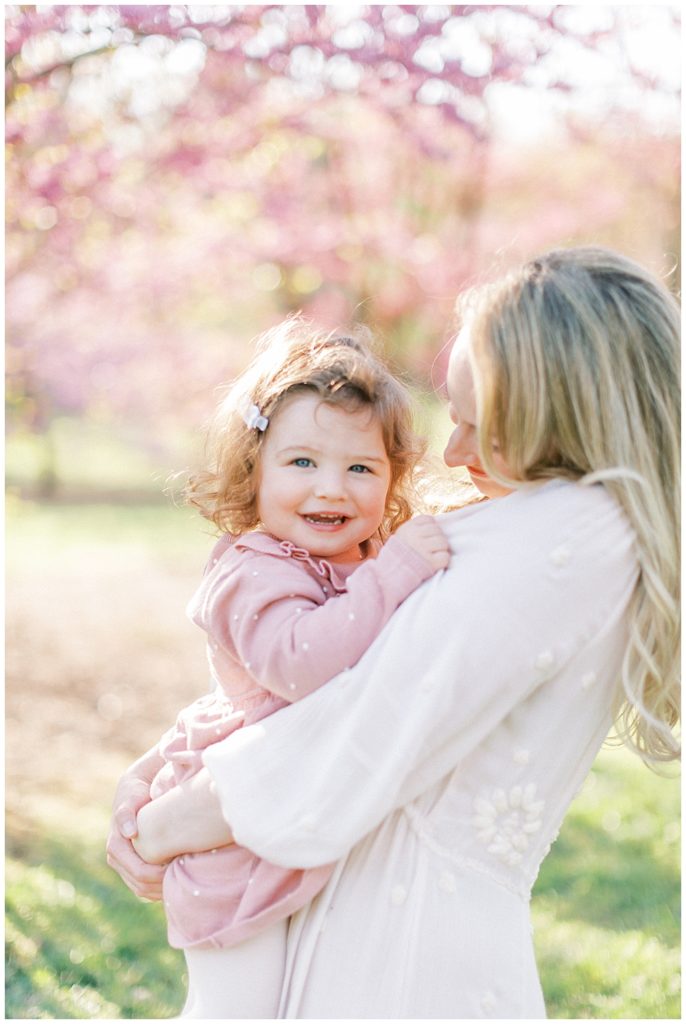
{"left": 110, "top": 249, "right": 679, "bottom": 1019}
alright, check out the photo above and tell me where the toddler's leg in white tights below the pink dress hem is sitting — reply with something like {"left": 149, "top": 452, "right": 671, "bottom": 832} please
{"left": 181, "top": 921, "right": 288, "bottom": 1020}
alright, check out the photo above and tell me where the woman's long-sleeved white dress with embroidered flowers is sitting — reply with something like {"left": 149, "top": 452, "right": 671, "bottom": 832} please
{"left": 205, "top": 480, "right": 638, "bottom": 1019}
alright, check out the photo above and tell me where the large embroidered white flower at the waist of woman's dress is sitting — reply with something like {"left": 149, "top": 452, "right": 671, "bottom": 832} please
{"left": 472, "top": 782, "right": 545, "bottom": 867}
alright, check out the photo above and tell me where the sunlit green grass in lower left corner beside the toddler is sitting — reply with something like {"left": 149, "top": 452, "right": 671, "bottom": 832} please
{"left": 5, "top": 816, "right": 184, "bottom": 1020}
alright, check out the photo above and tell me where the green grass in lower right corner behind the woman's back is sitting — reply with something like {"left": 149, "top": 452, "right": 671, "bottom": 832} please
{"left": 532, "top": 749, "right": 681, "bottom": 1019}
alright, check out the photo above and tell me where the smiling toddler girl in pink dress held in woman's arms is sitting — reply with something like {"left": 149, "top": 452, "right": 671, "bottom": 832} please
{"left": 134, "top": 318, "right": 449, "bottom": 1018}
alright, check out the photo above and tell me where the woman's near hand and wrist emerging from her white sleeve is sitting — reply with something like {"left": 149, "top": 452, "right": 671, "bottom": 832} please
{"left": 132, "top": 768, "right": 233, "bottom": 864}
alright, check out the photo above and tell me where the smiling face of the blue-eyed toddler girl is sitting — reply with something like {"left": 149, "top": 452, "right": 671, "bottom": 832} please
{"left": 257, "top": 394, "right": 391, "bottom": 562}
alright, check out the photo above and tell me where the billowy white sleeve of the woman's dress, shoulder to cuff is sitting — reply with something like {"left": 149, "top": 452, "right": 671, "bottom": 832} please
{"left": 204, "top": 481, "right": 637, "bottom": 867}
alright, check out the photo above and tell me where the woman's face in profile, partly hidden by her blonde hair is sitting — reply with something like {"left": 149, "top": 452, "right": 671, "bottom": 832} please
{"left": 443, "top": 330, "right": 511, "bottom": 498}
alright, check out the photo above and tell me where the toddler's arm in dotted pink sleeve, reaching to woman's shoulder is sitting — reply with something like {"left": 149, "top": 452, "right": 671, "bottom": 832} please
{"left": 208, "top": 537, "right": 433, "bottom": 703}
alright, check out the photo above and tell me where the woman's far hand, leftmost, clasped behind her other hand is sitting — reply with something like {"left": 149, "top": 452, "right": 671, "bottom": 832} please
{"left": 108, "top": 748, "right": 164, "bottom": 900}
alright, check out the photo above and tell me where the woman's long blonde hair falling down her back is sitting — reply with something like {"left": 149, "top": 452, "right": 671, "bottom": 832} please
{"left": 463, "top": 247, "right": 680, "bottom": 762}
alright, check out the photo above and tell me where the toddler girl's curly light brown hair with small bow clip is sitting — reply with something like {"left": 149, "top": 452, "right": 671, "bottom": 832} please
{"left": 185, "top": 315, "right": 425, "bottom": 540}
